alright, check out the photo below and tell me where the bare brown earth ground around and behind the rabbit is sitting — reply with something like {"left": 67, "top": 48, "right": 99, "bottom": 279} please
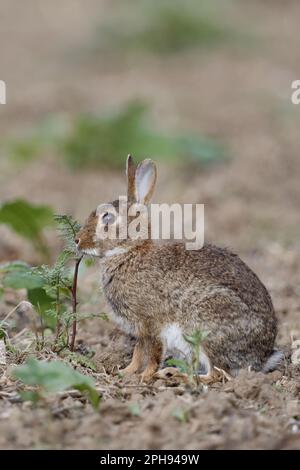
{"left": 0, "top": 0, "right": 300, "bottom": 449}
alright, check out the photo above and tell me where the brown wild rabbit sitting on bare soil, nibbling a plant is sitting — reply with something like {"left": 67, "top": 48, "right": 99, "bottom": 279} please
{"left": 76, "top": 156, "right": 282, "bottom": 381}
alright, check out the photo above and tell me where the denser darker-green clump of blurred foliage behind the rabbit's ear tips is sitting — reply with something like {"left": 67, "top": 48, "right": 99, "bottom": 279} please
{"left": 62, "top": 102, "right": 158, "bottom": 168}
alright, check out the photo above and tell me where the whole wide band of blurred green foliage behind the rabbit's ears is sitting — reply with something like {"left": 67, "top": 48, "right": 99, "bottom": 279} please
{"left": 1, "top": 101, "right": 227, "bottom": 169}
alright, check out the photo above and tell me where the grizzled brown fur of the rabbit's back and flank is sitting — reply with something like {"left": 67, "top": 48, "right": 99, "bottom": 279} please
{"left": 104, "top": 243, "right": 277, "bottom": 370}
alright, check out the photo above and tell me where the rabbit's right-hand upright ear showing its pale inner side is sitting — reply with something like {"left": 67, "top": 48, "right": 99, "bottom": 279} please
{"left": 135, "top": 158, "right": 157, "bottom": 204}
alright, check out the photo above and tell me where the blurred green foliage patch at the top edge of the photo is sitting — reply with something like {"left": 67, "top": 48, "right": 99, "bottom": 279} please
{"left": 94, "top": 0, "right": 237, "bottom": 55}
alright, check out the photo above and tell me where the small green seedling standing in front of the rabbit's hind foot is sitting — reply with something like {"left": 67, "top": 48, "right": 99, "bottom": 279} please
{"left": 167, "top": 330, "right": 209, "bottom": 386}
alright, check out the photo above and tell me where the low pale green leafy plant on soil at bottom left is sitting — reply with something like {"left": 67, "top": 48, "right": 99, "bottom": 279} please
{"left": 13, "top": 358, "right": 100, "bottom": 409}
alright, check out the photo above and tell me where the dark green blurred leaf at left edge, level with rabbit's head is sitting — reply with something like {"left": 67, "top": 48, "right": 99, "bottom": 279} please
{"left": 0, "top": 199, "right": 53, "bottom": 258}
